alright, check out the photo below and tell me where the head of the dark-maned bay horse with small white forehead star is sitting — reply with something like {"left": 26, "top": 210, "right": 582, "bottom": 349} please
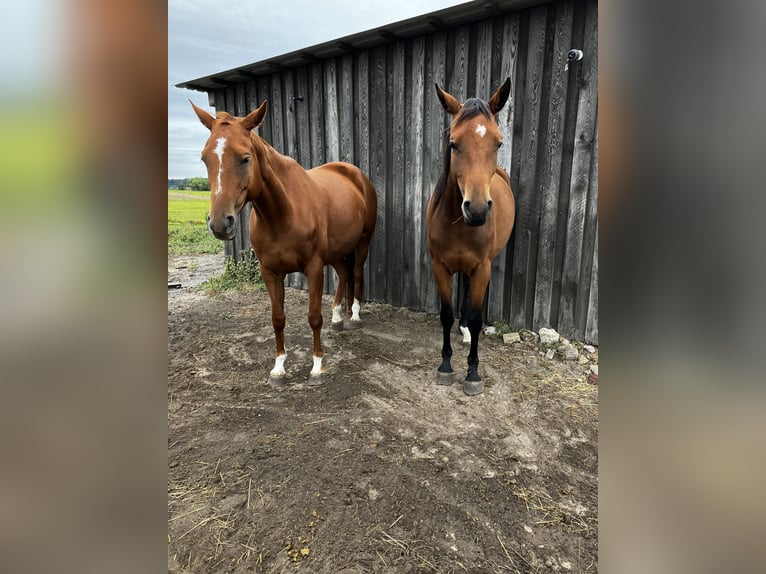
{"left": 436, "top": 78, "right": 511, "bottom": 226}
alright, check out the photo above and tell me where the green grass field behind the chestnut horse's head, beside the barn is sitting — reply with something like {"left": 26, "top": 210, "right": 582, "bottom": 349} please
{"left": 168, "top": 190, "right": 223, "bottom": 255}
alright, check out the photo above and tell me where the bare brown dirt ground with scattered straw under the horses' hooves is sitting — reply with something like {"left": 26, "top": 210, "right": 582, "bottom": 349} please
{"left": 168, "top": 255, "right": 598, "bottom": 574}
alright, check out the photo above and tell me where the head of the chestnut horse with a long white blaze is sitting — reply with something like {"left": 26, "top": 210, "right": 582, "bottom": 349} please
{"left": 190, "top": 102, "right": 267, "bottom": 239}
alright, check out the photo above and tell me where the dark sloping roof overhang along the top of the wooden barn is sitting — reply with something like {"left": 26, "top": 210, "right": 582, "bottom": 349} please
{"left": 176, "top": 0, "right": 551, "bottom": 92}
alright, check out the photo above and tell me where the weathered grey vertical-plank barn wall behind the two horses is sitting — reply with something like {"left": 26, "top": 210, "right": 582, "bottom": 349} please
{"left": 215, "top": 0, "right": 598, "bottom": 343}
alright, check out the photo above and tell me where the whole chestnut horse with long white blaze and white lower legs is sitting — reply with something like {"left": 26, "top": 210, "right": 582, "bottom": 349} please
{"left": 190, "top": 101, "right": 378, "bottom": 387}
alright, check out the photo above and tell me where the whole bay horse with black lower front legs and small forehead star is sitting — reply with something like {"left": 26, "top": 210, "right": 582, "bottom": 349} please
{"left": 426, "top": 78, "right": 516, "bottom": 395}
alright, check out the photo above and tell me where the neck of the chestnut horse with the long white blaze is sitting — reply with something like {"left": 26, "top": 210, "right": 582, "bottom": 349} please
{"left": 248, "top": 133, "right": 292, "bottom": 221}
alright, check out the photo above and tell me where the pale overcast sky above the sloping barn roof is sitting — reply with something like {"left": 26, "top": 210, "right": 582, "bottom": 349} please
{"left": 168, "top": 0, "right": 464, "bottom": 178}
